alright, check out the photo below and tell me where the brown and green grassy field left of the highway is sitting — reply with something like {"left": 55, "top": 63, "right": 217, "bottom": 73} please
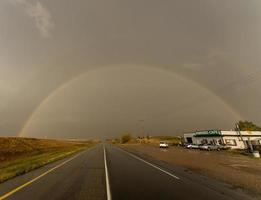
{"left": 0, "top": 137, "right": 95, "bottom": 183}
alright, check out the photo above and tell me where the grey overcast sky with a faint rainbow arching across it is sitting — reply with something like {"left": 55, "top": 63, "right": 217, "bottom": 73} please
{"left": 0, "top": 0, "right": 261, "bottom": 138}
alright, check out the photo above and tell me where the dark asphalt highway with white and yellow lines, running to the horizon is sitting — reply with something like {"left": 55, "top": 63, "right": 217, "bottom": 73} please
{"left": 0, "top": 144, "right": 252, "bottom": 200}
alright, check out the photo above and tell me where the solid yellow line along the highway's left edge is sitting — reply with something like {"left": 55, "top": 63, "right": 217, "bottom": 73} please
{"left": 0, "top": 152, "right": 83, "bottom": 200}
